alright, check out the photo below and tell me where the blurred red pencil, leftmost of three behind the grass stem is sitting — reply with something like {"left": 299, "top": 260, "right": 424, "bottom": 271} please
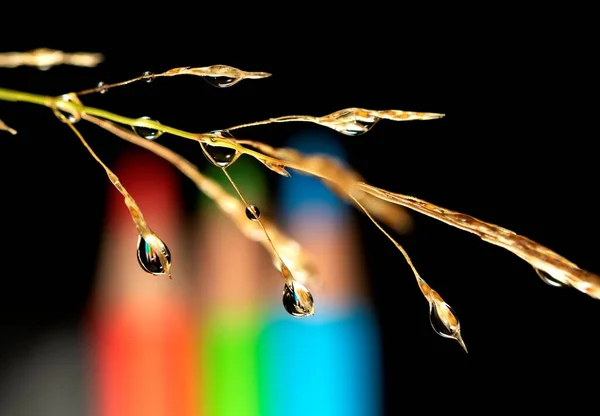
{"left": 85, "top": 151, "right": 194, "bottom": 416}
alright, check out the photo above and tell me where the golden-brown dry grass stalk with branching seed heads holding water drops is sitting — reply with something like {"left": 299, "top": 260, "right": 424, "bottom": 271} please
{"left": 0, "top": 54, "right": 600, "bottom": 350}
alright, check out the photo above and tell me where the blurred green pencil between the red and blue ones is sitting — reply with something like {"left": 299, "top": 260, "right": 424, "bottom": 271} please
{"left": 194, "top": 157, "right": 272, "bottom": 416}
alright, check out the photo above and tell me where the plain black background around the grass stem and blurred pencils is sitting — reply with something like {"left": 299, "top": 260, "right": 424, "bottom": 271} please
{"left": 0, "top": 10, "right": 600, "bottom": 414}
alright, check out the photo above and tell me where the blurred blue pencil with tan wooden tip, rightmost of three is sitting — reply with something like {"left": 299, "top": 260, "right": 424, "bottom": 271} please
{"left": 260, "top": 131, "right": 383, "bottom": 416}
